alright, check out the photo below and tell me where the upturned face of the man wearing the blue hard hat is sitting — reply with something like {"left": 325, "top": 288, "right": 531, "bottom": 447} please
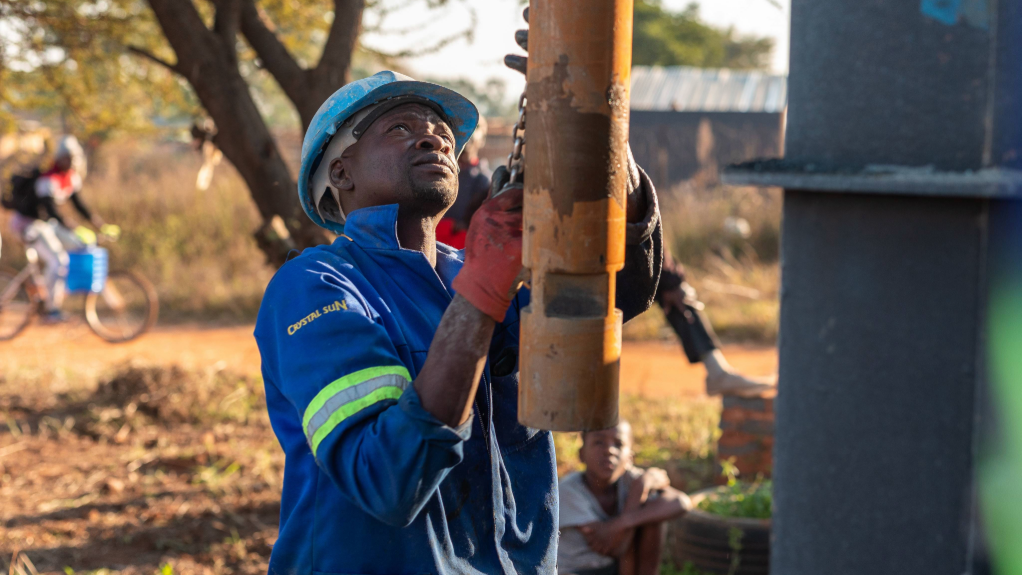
{"left": 330, "top": 103, "right": 458, "bottom": 217}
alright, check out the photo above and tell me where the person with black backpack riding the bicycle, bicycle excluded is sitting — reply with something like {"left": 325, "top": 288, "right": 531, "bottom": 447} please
{"left": 5, "top": 136, "right": 115, "bottom": 321}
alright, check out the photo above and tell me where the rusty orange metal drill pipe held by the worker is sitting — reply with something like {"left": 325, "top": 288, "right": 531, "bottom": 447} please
{"left": 518, "top": 0, "right": 633, "bottom": 431}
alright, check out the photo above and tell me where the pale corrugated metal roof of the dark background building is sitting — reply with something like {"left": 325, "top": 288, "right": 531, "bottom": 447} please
{"left": 632, "top": 66, "right": 788, "bottom": 112}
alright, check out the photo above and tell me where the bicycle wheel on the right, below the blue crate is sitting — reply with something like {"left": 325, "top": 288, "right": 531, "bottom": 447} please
{"left": 85, "top": 272, "right": 159, "bottom": 343}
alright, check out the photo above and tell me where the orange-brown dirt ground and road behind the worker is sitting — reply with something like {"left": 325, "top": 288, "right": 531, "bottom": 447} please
{"left": 0, "top": 326, "right": 777, "bottom": 575}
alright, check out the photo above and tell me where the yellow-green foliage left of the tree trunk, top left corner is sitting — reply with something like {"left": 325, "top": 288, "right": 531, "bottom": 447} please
{"left": 0, "top": 0, "right": 197, "bottom": 139}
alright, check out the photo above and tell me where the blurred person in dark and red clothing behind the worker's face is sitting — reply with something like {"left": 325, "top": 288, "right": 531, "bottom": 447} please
{"left": 436, "top": 115, "right": 490, "bottom": 249}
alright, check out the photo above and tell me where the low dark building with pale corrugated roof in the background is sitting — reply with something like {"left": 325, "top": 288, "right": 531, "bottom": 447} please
{"left": 629, "top": 66, "right": 787, "bottom": 191}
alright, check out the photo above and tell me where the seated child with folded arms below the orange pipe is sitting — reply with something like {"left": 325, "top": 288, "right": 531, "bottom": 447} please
{"left": 557, "top": 421, "right": 692, "bottom": 575}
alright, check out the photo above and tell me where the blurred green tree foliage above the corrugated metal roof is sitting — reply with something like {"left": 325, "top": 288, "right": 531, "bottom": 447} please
{"left": 632, "top": 0, "right": 774, "bottom": 69}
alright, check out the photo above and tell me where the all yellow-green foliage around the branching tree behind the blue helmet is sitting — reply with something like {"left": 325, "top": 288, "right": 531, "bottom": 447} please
{"left": 0, "top": 0, "right": 472, "bottom": 137}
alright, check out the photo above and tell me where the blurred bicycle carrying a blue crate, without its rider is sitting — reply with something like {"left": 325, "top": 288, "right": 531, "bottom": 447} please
{"left": 0, "top": 225, "right": 159, "bottom": 343}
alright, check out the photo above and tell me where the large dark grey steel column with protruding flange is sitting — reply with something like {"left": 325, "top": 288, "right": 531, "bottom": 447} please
{"left": 726, "top": 0, "right": 1022, "bottom": 575}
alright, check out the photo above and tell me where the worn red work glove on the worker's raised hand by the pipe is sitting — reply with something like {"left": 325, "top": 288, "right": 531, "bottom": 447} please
{"left": 452, "top": 185, "right": 523, "bottom": 322}
